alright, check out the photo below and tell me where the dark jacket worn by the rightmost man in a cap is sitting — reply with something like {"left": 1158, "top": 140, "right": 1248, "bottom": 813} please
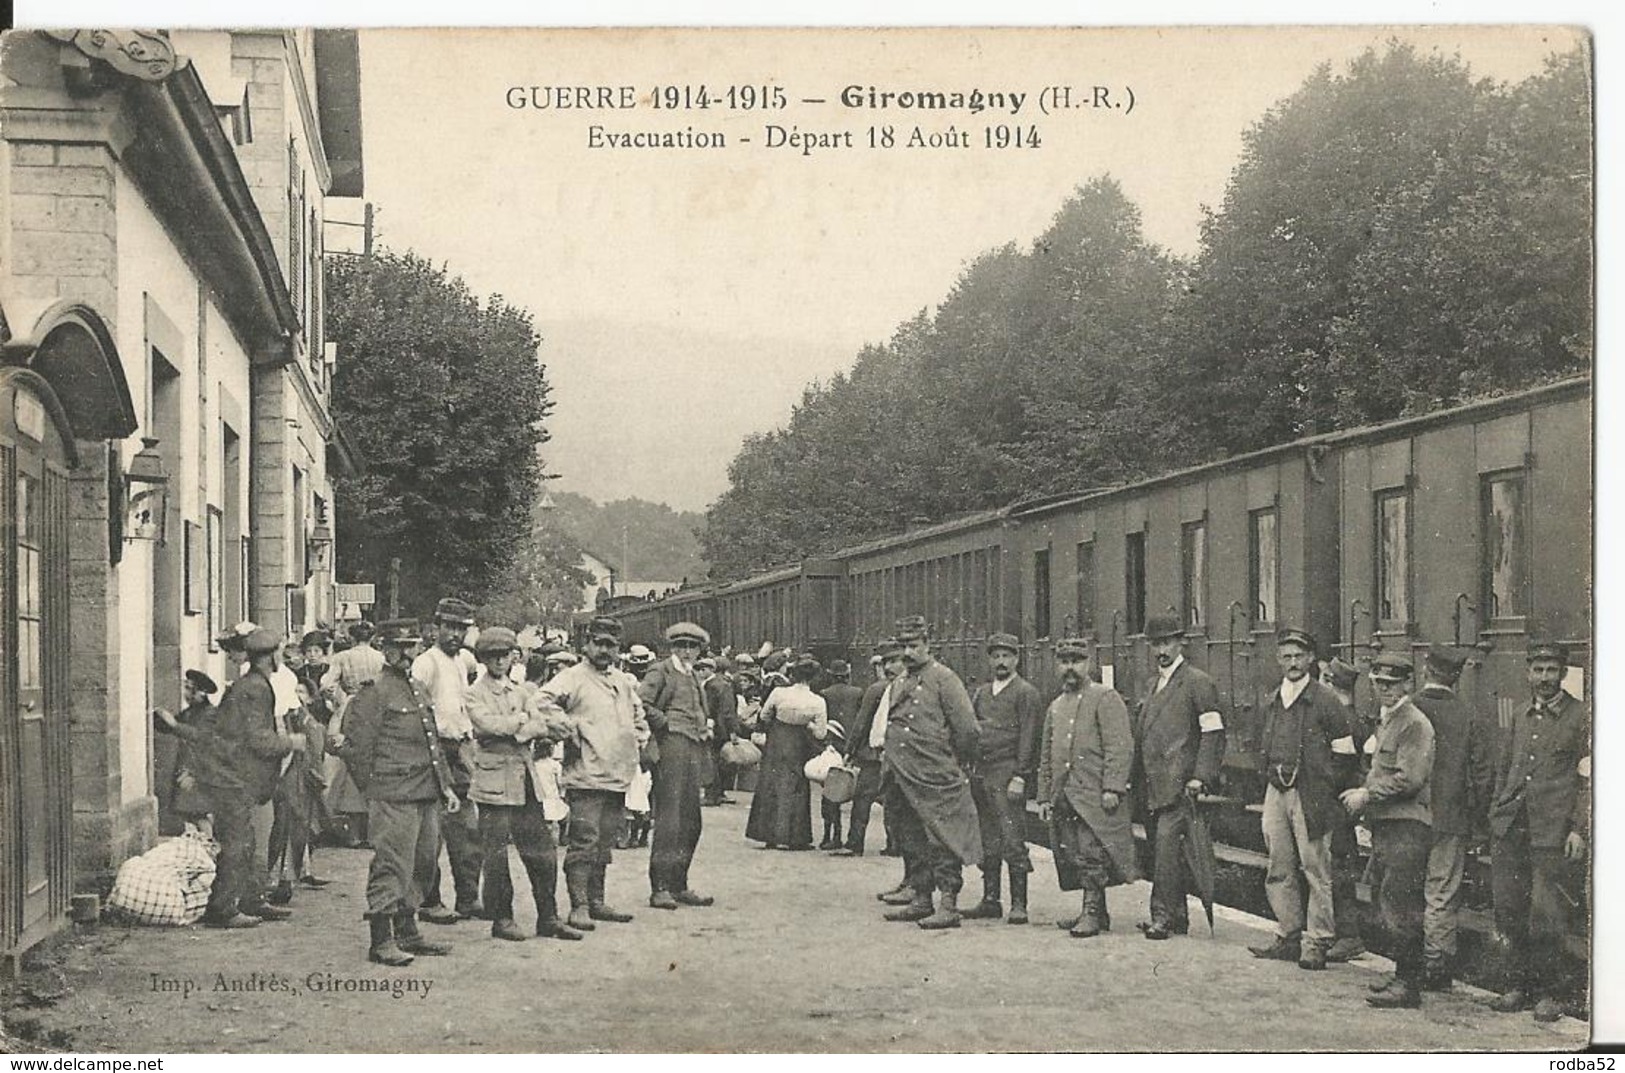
{"left": 1490, "top": 693, "right": 1591, "bottom": 849}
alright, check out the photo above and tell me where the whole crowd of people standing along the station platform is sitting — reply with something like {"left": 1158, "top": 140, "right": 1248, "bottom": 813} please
{"left": 154, "top": 598, "right": 1591, "bottom": 1021}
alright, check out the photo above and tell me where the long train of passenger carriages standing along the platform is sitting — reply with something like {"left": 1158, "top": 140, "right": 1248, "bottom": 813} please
{"left": 594, "top": 377, "right": 1593, "bottom": 955}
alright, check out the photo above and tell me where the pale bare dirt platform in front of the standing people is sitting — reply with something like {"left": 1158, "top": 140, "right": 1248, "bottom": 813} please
{"left": 5, "top": 795, "right": 1586, "bottom": 1053}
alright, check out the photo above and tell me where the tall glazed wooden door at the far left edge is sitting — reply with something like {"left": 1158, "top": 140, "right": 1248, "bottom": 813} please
{"left": 0, "top": 377, "right": 70, "bottom": 949}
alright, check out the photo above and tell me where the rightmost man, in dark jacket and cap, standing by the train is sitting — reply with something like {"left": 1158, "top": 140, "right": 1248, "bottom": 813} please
{"left": 1490, "top": 642, "right": 1591, "bottom": 1021}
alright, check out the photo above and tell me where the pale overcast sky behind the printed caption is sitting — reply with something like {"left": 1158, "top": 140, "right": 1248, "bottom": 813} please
{"left": 328, "top": 28, "right": 1573, "bottom": 509}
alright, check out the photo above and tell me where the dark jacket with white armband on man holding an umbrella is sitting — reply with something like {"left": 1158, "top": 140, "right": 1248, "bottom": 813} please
{"left": 1134, "top": 660, "right": 1224, "bottom": 810}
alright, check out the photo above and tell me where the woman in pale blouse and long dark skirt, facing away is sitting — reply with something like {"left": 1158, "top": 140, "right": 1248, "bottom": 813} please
{"left": 744, "top": 658, "right": 829, "bottom": 850}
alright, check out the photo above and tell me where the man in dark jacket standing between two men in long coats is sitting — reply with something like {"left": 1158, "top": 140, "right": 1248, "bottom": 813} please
{"left": 964, "top": 634, "right": 1043, "bottom": 923}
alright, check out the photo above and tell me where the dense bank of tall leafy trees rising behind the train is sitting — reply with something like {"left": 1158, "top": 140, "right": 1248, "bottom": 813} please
{"left": 704, "top": 44, "right": 1593, "bottom": 577}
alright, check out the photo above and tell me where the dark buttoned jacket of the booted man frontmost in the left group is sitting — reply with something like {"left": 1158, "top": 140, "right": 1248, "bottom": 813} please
{"left": 338, "top": 665, "right": 452, "bottom": 801}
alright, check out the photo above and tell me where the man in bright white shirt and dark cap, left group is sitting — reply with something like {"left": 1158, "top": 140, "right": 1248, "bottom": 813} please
{"left": 411, "top": 598, "right": 486, "bottom": 923}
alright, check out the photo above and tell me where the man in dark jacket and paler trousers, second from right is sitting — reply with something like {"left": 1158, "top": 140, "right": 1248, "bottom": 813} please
{"left": 1412, "top": 647, "right": 1495, "bottom": 992}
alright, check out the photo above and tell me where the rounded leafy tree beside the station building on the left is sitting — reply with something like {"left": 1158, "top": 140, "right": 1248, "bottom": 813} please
{"left": 327, "top": 252, "right": 574, "bottom": 615}
